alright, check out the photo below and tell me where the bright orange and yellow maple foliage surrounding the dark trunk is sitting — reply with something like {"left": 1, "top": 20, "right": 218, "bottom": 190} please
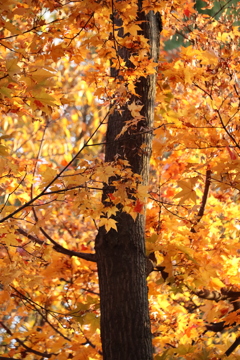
{"left": 0, "top": 0, "right": 240, "bottom": 360}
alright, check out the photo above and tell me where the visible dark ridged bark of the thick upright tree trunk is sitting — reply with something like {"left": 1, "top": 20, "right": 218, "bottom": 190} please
{"left": 95, "top": 1, "right": 161, "bottom": 360}
